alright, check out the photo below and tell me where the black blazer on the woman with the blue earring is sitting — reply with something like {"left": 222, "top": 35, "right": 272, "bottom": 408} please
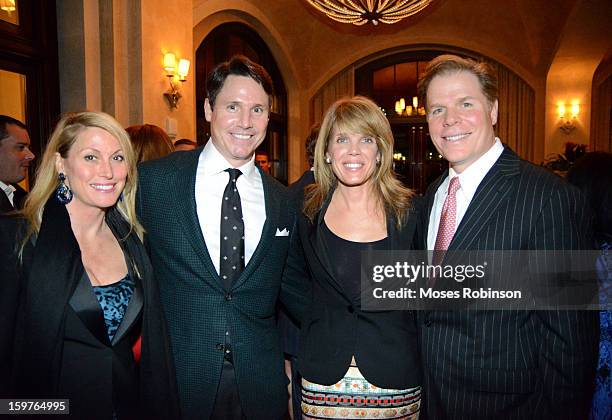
{"left": 2, "top": 198, "right": 179, "bottom": 418}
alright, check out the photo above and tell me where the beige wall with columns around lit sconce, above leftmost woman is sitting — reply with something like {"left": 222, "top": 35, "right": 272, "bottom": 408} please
{"left": 57, "top": 0, "right": 195, "bottom": 138}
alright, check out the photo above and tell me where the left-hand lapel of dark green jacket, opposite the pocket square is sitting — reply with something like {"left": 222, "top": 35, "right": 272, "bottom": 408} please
{"left": 168, "top": 149, "right": 223, "bottom": 290}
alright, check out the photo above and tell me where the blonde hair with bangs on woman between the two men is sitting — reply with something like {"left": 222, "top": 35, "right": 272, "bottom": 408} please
{"left": 304, "top": 96, "right": 414, "bottom": 227}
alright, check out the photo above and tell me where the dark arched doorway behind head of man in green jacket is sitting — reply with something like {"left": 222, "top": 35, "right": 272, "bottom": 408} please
{"left": 196, "top": 22, "right": 288, "bottom": 184}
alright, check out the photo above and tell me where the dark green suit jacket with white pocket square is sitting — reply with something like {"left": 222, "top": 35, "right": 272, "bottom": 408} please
{"left": 138, "top": 148, "right": 308, "bottom": 419}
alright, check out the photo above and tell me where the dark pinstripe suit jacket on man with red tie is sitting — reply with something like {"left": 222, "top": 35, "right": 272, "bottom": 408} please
{"left": 419, "top": 147, "right": 598, "bottom": 419}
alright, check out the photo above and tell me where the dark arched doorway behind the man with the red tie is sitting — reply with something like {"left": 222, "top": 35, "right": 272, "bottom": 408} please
{"left": 354, "top": 47, "right": 535, "bottom": 193}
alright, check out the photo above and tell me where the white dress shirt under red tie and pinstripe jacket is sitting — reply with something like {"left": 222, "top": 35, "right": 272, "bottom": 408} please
{"left": 427, "top": 137, "right": 504, "bottom": 250}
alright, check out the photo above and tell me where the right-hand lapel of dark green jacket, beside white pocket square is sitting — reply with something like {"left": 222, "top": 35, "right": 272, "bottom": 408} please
{"left": 232, "top": 167, "right": 276, "bottom": 289}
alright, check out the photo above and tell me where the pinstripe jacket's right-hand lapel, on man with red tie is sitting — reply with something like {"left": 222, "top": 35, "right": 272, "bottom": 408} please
{"left": 448, "top": 148, "right": 520, "bottom": 250}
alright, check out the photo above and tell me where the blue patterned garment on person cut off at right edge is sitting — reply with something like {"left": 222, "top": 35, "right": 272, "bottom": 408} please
{"left": 590, "top": 242, "right": 612, "bottom": 420}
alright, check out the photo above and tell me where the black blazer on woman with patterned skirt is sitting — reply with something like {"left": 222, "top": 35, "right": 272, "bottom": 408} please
{"left": 287, "top": 194, "right": 421, "bottom": 389}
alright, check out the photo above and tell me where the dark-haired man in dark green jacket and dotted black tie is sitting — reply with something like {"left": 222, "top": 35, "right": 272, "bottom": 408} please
{"left": 138, "top": 56, "right": 308, "bottom": 419}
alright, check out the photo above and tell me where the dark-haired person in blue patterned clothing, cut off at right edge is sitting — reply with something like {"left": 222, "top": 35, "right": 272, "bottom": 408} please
{"left": 567, "top": 152, "right": 612, "bottom": 420}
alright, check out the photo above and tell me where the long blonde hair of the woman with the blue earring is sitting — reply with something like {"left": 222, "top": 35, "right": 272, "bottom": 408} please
{"left": 23, "top": 111, "right": 144, "bottom": 243}
